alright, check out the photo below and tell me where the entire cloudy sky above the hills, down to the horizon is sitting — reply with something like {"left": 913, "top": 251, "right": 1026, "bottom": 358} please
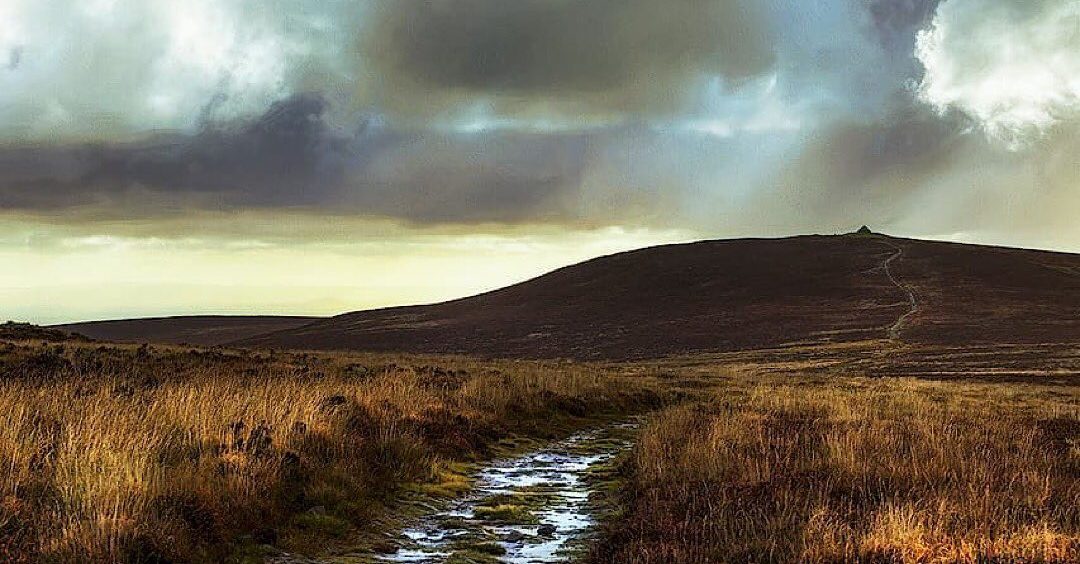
{"left": 0, "top": 0, "right": 1080, "bottom": 323}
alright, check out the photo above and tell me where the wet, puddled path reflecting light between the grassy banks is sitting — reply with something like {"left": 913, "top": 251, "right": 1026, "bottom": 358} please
{"left": 379, "top": 422, "right": 636, "bottom": 563}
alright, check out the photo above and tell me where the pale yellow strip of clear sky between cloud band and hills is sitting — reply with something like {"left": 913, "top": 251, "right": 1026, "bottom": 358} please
{"left": 0, "top": 213, "right": 694, "bottom": 323}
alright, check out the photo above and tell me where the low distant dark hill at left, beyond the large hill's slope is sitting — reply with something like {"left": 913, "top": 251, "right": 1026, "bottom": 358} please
{"left": 54, "top": 315, "right": 319, "bottom": 346}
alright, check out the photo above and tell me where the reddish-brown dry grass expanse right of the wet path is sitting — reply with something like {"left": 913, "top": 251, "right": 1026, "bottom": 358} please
{"left": 593, "top": 378, "right": 1080, "bottom": 563}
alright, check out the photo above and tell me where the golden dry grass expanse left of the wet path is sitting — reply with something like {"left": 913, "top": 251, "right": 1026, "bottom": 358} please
{"left": 0, "top": 337, "right": 658, "bottom": 562}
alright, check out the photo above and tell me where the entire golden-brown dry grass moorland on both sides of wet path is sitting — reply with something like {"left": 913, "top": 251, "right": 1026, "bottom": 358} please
{"left": 0, "top": 321, "right": 1080, "bottom": 563}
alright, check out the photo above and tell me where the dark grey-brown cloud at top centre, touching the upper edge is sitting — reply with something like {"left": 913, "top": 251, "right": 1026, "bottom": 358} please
{"left": 361, "top": 0, "right": 773, "bottom": 117}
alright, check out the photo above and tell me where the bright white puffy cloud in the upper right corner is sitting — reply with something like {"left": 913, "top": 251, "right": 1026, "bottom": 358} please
{"left": 916, "top": 0, "right": 1080, "bottom": 148}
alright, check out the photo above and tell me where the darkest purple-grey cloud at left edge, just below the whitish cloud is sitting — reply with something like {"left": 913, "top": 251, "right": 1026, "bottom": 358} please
{"left": 0, "top": 96, "right": 349, "bottom": 209}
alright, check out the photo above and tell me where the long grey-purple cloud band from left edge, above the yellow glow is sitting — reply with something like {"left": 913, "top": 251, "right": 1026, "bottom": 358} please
{"left": 0, "top": 95, "right": 585, "bottom": 223}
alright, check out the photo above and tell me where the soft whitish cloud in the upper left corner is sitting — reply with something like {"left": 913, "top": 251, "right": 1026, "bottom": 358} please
{"left": 0, "top": 0, "right": 289, "bottom": 140}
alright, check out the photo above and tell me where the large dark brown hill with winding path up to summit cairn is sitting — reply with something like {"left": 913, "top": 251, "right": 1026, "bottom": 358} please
{"left": 237, "top": 236, "right": 1080, "bottom": 359}
